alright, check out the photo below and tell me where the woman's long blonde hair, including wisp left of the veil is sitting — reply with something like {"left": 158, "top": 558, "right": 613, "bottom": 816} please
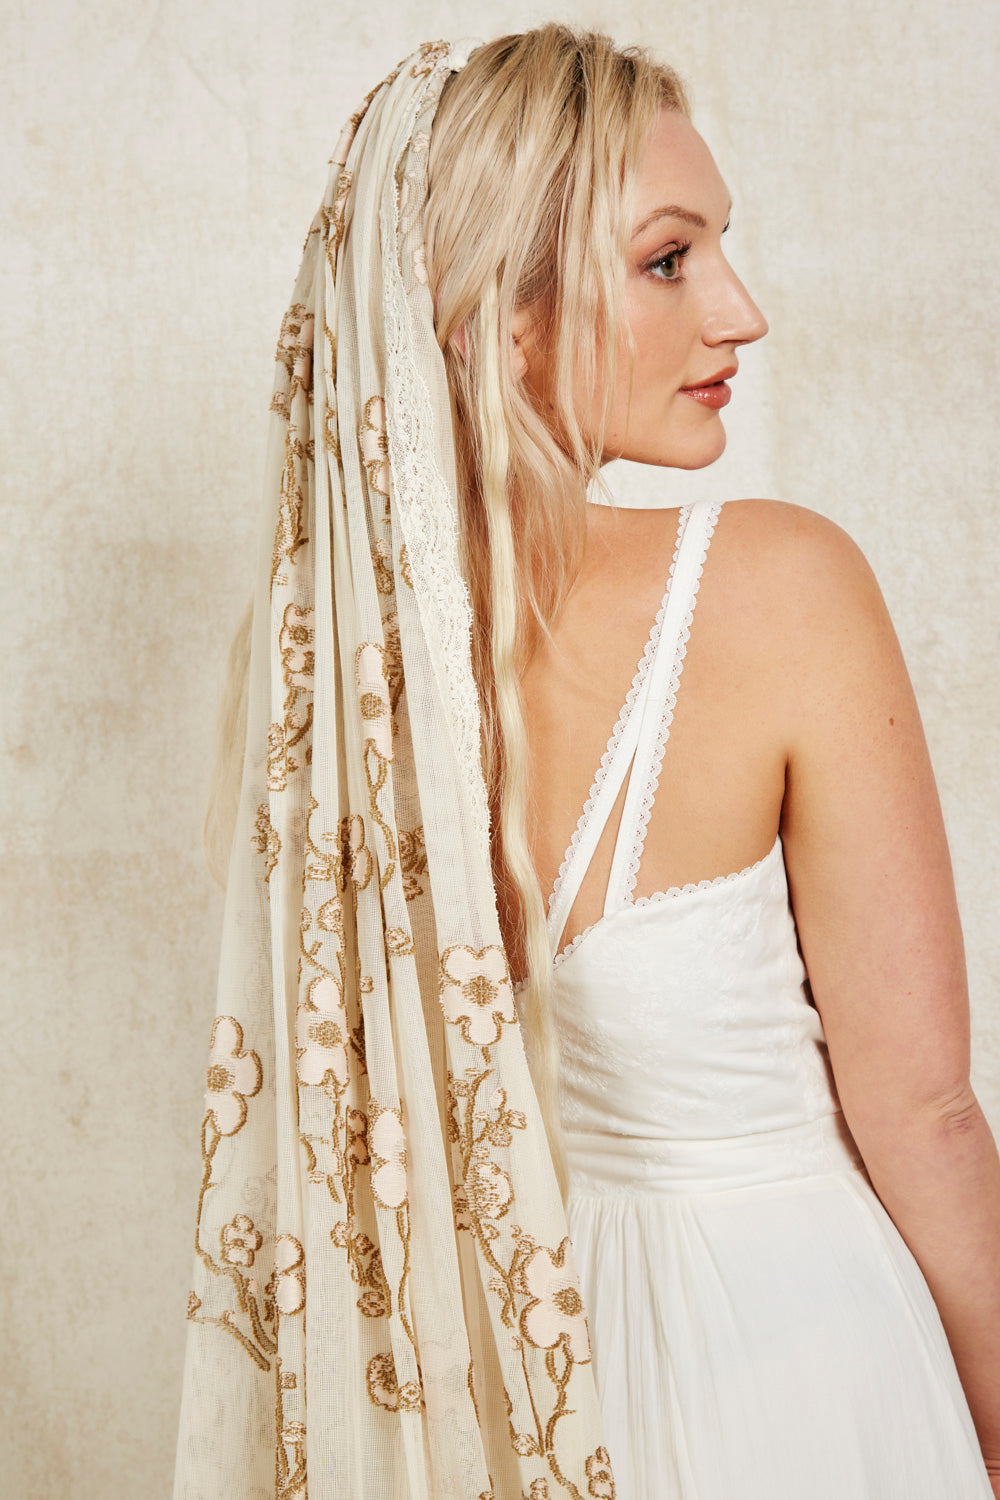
{"left": 202, "top": 24, "right": 687, "bottom": 1193}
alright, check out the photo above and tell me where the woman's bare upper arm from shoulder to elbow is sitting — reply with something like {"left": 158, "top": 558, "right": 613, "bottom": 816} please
{"left": 774, "top": 507, "right": 969, "bottom": 1154}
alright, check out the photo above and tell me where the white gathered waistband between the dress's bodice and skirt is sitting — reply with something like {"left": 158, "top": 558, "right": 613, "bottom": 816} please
{"left": 565, "top": 1110, "right": 864, "bottom": 1196}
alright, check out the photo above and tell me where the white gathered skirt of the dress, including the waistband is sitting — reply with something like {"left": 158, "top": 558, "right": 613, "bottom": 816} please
{"left": 570, "top": 1118, "right": 993, "bottom": 1500}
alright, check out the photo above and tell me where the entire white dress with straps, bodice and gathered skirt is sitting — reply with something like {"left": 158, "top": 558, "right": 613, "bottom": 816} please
{"left": 549, "top": 504, "right": 993, "bottom": 1500}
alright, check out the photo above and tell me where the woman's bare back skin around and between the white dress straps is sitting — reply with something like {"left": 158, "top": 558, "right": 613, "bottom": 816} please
{"left": 523, "top": 503, "right": 787, "bottom": 972}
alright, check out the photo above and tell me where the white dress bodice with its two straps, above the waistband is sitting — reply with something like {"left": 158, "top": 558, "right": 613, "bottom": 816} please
{"left": 549, "top": 506, "right": 840, "bottom": 1158}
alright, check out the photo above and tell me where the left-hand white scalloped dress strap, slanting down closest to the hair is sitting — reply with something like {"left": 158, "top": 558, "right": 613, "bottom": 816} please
{"left": 547, "top": 503, "right": 718, "bottom": 956}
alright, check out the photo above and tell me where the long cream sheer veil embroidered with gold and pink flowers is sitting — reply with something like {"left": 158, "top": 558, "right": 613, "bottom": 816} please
{"left": 174, "top": 35, "right": 615, "bottom": 1500}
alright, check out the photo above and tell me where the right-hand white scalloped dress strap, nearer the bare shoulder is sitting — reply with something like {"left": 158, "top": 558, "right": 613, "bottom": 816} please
{"left": 604, "top": 500, "right": 720, "bottom": 917}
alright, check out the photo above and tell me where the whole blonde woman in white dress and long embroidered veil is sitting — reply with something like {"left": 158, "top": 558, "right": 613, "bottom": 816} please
{"left": 175, "top": 27, "right": 1000, "bottom": 1500}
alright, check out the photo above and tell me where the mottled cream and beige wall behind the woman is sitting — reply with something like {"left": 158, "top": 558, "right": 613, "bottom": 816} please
{"left": 0, "top": 0, "right": 1000, "bottom": 1500}
